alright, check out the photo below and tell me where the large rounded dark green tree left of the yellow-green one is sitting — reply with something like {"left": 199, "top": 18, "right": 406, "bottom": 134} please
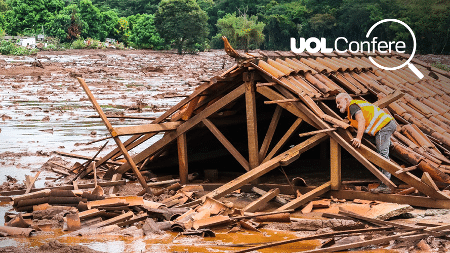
{"left": 155, "top": 0, "right": 208, "bottom": 54}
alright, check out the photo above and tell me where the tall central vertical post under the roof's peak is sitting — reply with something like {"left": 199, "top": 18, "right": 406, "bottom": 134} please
{"left": 244, "top": 72, "right": 259, "bottom": 169}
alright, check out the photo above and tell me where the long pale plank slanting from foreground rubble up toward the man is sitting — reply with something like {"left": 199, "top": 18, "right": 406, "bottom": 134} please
{"left": 206, "top": 133, "right": 327, "bottom": 202}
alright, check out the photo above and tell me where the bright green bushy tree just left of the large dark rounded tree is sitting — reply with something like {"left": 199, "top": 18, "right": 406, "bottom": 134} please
{"left": 130, "top": 14, "right": 164, "bottom": 49}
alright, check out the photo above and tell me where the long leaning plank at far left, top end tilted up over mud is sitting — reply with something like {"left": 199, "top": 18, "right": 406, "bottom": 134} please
{"left": 77, "top": 77, "right": 151, "bottom": 193}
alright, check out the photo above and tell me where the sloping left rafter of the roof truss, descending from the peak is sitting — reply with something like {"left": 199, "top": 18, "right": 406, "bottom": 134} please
{"left": 115, "top": 85, "right": 245, "bottom": 174}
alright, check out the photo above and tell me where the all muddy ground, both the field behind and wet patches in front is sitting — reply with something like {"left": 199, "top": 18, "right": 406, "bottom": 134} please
{"left": 0, "top": 50, "right": 450, "bottom": 252}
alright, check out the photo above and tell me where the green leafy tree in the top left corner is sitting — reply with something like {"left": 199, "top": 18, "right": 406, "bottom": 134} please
{"left": 5, "top": 0, "right": 64, "bottom": 35}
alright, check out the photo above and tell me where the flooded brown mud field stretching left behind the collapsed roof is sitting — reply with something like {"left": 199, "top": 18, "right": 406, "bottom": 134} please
{"left": 0, "top": 50, "right": 234, "bottom": 190}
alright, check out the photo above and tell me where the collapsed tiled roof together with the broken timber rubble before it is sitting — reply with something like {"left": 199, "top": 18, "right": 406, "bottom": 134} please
{"left": 4, "top": 39, "right": 450, "bottom": 252}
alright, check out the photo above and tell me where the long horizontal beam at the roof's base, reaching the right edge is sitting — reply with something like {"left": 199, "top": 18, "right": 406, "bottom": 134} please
{"left": 329, "top": 190, "right": 450, "bottom": 209}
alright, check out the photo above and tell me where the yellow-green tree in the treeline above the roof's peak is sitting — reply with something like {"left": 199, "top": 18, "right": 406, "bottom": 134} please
{"left": 216, "top": 12, "right": 266, "bottom": 51}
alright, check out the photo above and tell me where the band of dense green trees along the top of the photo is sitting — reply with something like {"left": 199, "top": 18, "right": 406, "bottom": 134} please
{"left": 0, "top": 0, "right": 450, "bottom": 54}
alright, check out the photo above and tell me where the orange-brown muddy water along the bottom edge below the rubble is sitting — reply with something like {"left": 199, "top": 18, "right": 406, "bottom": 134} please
{"left": 3, "top": 229, "right": 320, "bottom": 253}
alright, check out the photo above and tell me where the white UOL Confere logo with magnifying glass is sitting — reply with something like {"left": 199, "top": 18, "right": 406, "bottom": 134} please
{"left": 291, "top": 19, "right": 424, "bottom": 79}
